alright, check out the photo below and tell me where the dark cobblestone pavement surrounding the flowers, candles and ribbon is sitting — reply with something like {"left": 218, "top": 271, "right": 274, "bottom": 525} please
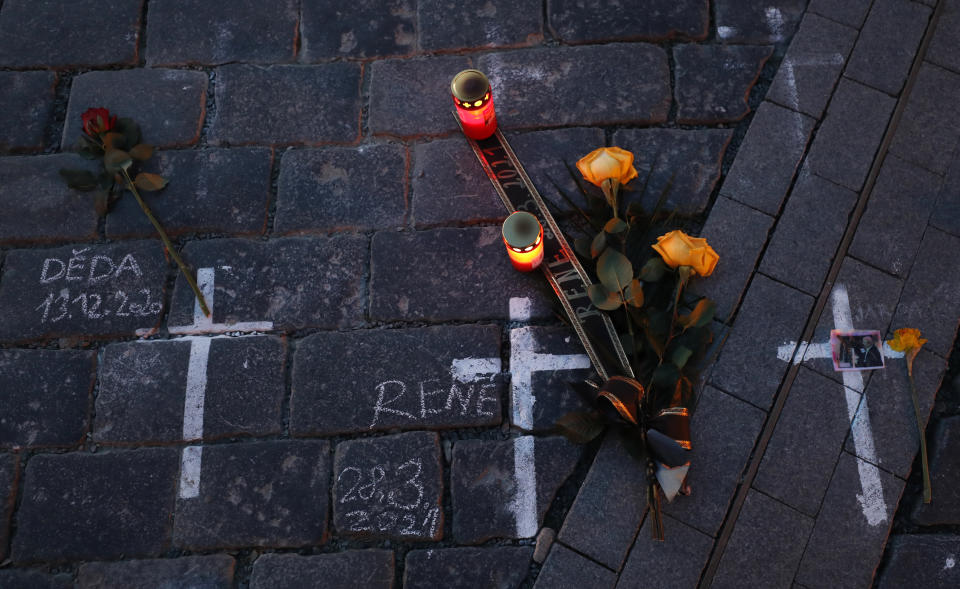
{"left": 0, "top": 0, "right": 960, "bottom": 589}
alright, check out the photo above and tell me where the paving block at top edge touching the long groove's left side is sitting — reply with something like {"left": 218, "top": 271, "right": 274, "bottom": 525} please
{"left": 844, "top": 0, "right": 931, "bottom": 95}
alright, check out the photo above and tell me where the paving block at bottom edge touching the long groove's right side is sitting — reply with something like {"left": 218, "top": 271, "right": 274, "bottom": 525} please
{"left": 711, "top": 490, "right": 814, "bottom": 589}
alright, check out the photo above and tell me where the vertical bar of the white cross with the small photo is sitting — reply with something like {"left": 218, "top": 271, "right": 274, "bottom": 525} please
{"left": 830, "top": 284, "right": 887, "bottom": 526}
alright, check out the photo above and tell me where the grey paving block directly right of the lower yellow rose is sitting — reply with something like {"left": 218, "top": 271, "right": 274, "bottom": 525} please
{"left": 690, "top": 195, "right": 774, "bottom": 319}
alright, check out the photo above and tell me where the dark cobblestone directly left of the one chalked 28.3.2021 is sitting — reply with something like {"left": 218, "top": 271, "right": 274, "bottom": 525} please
{"left": 170, "top": 440, "right": 330, "bottom": 550}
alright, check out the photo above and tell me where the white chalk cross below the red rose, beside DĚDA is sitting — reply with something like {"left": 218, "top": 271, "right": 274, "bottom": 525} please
{"left": 169, "top": 268, "right": 273, "bottom": 499}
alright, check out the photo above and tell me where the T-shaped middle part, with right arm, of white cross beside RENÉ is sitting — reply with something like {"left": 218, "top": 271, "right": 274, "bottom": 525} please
{"left": 510, "top": 327, "right": 591, "bottom": 430}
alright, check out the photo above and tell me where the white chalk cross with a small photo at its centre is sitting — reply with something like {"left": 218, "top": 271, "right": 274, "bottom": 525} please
{"left": 777, "top": 284, "right": 888, "bottom": 526}
